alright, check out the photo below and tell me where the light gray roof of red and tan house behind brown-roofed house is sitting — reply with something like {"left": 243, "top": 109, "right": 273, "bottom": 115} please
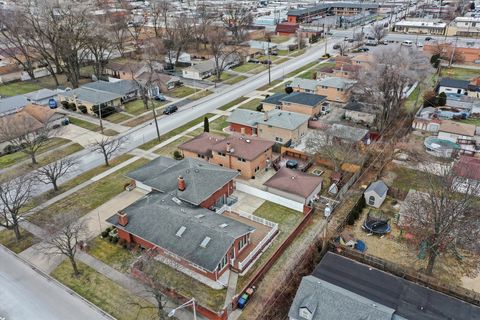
{"left": 227, "top": 109, "right": 309, "bottom": 130}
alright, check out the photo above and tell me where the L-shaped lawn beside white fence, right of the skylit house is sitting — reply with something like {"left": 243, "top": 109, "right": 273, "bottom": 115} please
{"left": 237, "top": 201, "right": 303, "bottom": 290}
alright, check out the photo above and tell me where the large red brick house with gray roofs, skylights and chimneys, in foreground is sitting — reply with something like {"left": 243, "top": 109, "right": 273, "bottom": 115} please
{"left": 107, "top": 157, "right": 255, "bottom": 281}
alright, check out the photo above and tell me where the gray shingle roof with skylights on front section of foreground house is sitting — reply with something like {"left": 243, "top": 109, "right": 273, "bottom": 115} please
{"left": 107, "top": 191, "right": 255, "bottom": 272}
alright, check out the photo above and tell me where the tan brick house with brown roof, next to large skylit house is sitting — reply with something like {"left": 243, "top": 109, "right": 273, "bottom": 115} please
{"left": 178, "top": 132, "right": 275, "bottom": 179}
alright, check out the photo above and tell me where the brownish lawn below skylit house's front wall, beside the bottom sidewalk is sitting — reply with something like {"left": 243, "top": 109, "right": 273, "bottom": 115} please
{"left": 150, "top": 261, "right": 227, "bottom": 311}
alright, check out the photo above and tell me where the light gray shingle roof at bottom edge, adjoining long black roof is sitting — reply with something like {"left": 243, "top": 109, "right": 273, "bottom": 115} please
{"left": 288, "top": 276, "right": 395, "bottom": 320}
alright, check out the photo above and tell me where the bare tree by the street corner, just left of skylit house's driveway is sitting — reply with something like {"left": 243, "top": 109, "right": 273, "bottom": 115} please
{"left": 41, "top": 212, "right": 88, "bottom": 276}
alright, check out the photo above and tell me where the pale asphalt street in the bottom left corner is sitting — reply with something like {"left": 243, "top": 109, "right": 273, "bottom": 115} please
{"left": 0, "top": 246, "right": 111, "bottom": 320}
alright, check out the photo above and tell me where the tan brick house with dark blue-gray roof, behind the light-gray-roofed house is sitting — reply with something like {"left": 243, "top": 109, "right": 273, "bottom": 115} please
{"left": 262, "top": 92, "right": 326, "bottom": 117}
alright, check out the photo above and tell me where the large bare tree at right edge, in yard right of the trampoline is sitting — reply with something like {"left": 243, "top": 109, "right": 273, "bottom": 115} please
{"left": 402, "top": 163, "right": 480, "bottom": 275}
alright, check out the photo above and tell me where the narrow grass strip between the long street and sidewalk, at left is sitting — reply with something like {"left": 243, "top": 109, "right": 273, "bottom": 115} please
{"left": 23, "top": 154, "right": 133, "bottom": 211}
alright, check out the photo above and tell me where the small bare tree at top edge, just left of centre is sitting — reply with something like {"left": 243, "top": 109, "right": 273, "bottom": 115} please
{"left": 221, "top": 3, "right": 253, "bottom": 44}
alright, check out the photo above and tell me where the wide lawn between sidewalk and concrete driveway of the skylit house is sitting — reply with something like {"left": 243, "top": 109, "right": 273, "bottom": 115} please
{"left": 29, "top": 159, "right": 148, "bottom": 225}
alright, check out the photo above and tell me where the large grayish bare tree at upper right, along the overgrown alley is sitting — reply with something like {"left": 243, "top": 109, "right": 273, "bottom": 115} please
{"left": 354, "top": 47, "right": 430, "bottom": 133}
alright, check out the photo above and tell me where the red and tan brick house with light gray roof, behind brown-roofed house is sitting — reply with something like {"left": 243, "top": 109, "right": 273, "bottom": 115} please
{"left": 227, "top": 109, "right": 309, "bottom": 144}
